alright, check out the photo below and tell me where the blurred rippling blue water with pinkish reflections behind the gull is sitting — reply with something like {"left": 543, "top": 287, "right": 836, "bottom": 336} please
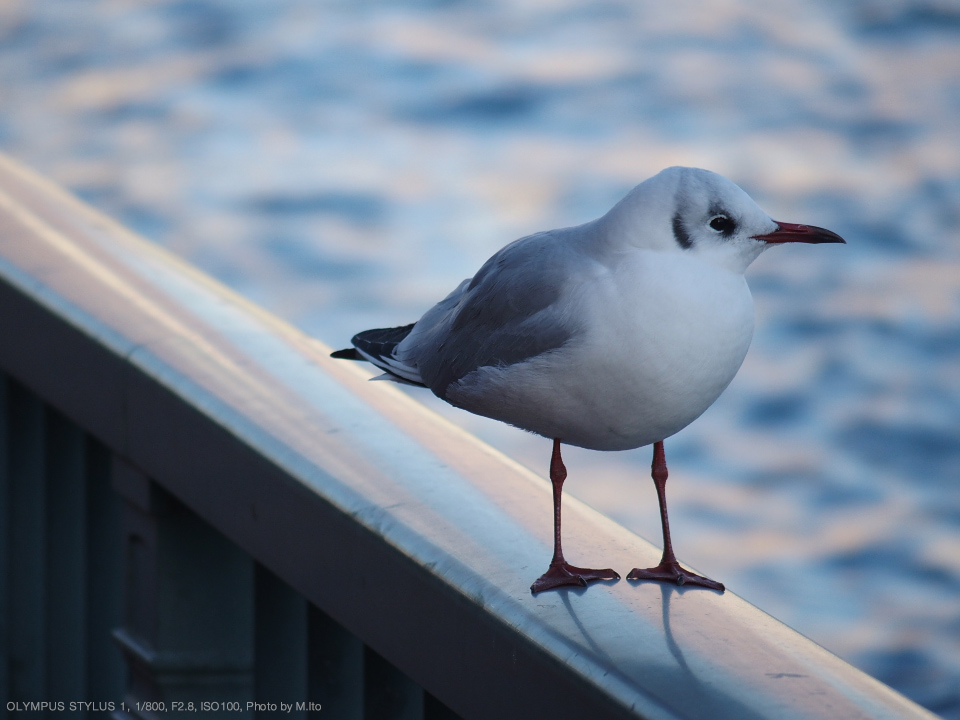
{"left": 0, "top": 0, "right": 960, "bottom": 718}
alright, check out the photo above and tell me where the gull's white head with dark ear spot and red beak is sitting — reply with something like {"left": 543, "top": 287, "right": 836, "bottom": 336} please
{"left": 603, "top": 167, "right": 844, "bottom": 273}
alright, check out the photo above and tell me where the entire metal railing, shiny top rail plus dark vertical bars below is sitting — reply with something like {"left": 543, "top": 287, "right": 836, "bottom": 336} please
{"left": 0, "top": 158, "right": 932, "bottom": 720}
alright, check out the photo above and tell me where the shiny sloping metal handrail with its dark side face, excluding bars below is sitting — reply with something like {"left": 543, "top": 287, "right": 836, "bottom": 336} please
{"left": 0, "top": 157, "right": 933, "bottom": 720}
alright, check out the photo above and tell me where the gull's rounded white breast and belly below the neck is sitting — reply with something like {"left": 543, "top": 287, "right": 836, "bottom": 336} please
{"left": 455, "top": 250, "right": 753, "bottom": 450}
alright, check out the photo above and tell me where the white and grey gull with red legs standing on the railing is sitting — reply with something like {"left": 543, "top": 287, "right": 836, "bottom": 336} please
{"left": 332, "top": 167, "right": 844, "bottom": 594}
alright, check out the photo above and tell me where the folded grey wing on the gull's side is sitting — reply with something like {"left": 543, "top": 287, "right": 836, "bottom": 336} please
{"left": 398, "top": 231, "right": 577, "bottom": 398}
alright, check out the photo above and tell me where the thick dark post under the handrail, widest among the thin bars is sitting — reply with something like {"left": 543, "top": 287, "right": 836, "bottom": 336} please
{"left": 113, "top": 458, "right": 253, "bottom": 720}
